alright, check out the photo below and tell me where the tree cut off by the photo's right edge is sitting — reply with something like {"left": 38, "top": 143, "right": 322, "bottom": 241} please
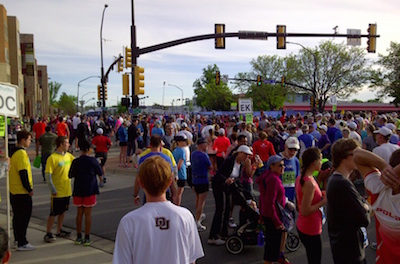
{"left": 370, "top": 42, "right": 400, "bottom": 107}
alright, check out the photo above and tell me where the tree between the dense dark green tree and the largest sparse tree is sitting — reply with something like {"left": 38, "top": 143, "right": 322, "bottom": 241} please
{"left": 234, "top": 55, "right": 287, "bottom": 110}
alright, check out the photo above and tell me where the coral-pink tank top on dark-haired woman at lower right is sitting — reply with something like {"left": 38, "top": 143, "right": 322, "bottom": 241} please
{"left": 295, "top": 177, "right": 322, "bottom": 236}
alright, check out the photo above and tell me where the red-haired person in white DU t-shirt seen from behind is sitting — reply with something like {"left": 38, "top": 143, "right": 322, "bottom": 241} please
{"left": 113, "top": 156, "right": 204, "bottom": 264}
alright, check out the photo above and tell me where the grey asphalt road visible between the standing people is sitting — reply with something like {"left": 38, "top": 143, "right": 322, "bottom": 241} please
{"left": 0, "top": 144, "right": 375, "bottom": 264}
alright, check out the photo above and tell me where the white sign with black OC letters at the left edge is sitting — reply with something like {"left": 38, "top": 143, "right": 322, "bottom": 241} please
{"left": 0, "top": 83, "right": 19, "bottom": 117}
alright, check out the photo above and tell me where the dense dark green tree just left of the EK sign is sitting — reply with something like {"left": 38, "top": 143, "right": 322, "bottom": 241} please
{"left": 193, "top": 64, "right": 232, "bottom": 111}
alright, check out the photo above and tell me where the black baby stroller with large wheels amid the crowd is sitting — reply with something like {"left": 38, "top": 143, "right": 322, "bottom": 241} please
{"left": 225, "top": 182, "right": 300, "bottom": 255}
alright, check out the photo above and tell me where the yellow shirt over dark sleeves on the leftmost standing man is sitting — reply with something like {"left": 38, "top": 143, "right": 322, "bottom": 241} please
{"left": 10, "top": 149, "right": 33, "bottom": 194}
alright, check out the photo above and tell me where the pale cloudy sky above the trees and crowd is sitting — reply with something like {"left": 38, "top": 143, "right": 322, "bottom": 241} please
{"left": 0, "top": 0, "right": 400, "bottom": 106}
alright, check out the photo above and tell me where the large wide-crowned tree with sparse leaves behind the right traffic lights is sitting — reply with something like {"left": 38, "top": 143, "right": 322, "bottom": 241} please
{"left": 286, "top": 41, "right": 370, "bottom": 112}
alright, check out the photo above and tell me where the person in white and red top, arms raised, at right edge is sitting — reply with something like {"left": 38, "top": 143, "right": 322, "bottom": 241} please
{"left": 353, "top": 149, "right": 400, "bottom": 263}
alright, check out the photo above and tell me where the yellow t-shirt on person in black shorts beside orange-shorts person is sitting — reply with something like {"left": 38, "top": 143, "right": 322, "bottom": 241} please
{"left": 45, "top": 152, "right": 75, "bottom": 198}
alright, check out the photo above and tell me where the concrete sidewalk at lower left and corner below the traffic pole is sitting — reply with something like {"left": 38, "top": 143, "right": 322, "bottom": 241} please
{"left": 0, "top": 143, "right": 137, "bottom": 264}
